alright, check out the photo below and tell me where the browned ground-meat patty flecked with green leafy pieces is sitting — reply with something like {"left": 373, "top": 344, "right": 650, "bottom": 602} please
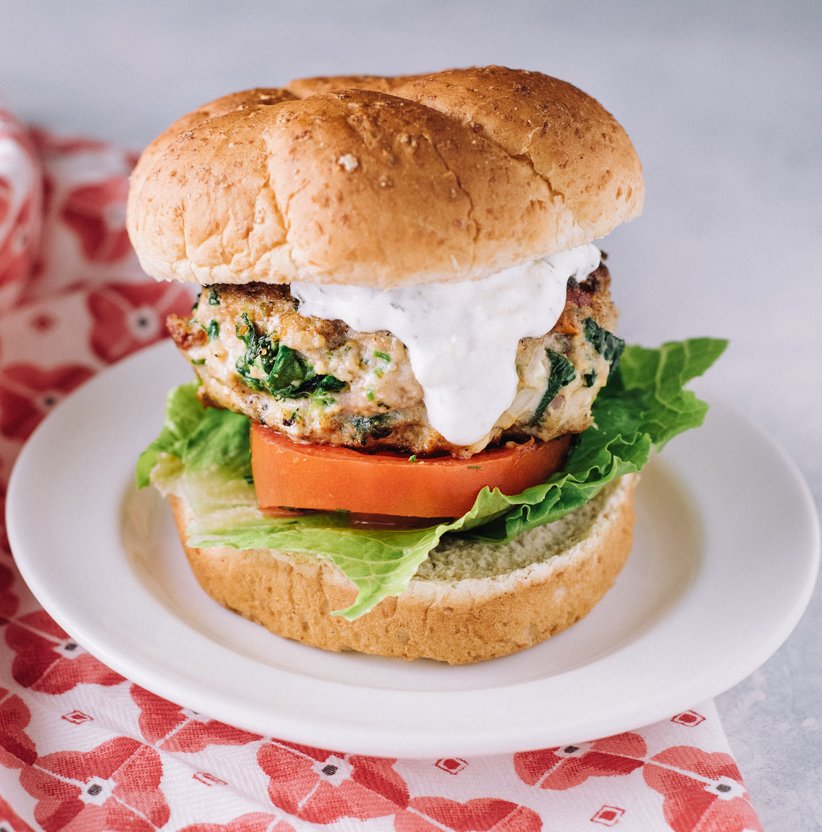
{"left": 169, "top": 265, "right": 616, "bottom": 456}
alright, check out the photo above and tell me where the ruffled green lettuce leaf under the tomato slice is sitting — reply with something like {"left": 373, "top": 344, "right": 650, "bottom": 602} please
{"left": 137, "top": 338, "right": 727, "bottom": 620}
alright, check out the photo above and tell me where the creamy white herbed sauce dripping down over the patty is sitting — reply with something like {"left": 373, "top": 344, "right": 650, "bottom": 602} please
{"left": 291, "top": 244, "right": 600, "bottom": 446}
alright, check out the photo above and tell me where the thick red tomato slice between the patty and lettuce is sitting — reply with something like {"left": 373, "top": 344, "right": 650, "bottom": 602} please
{"left": 251, "top": 424, "right": 571, "bottom": 517}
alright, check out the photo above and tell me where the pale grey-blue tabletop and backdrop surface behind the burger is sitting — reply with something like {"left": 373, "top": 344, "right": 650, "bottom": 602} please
{"left": 0, "top": 0, "right": 822, "bottom": 830}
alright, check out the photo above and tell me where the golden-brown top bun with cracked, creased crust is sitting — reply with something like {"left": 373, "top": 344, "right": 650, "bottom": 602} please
{"left": 128, "top": 66, "right": 644, "bottom": 288}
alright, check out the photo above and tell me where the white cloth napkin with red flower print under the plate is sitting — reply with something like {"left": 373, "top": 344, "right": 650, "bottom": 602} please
{"left": 0, "top": 110, "right": 761, "bottom": 832}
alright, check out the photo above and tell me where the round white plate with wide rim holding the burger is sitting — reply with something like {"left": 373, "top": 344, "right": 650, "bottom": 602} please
{"left": 8, "top": 343, "right": 819, "bottom": 757}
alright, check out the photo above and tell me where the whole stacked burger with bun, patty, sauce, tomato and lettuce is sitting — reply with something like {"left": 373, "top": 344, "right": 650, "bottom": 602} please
{"left": 128, "top": 67, "right": 724, "bottom": 664}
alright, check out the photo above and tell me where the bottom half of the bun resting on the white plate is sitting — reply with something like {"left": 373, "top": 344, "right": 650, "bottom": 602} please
{"left": 170, "top": 474, "right": 637, "bottom": 664}
